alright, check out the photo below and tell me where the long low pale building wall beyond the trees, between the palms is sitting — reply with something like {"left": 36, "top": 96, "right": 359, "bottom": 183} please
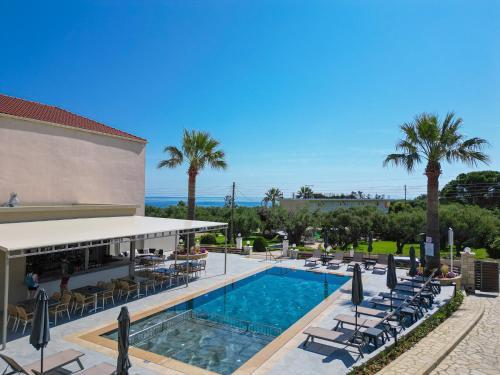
{"left": 280, "top": 199, "right": 390, "bottom": 212}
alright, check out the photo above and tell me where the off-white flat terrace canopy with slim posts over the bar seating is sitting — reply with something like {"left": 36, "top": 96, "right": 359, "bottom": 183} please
{"left": 0, "top": 216, "right": 227, "bottom": 347}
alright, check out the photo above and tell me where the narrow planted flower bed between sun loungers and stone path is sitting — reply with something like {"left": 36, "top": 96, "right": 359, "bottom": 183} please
{"left": 348, "top": 290, "right": 464, "bottom": 375}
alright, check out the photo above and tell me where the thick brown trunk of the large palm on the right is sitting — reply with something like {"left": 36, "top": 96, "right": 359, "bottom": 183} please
{"left": 425, "top": 163, "right": 441, "bottom": 273}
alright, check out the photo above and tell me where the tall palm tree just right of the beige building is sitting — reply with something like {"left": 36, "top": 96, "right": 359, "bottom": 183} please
{"left": 158, "top": 129, "right": 227, "bottom": 235}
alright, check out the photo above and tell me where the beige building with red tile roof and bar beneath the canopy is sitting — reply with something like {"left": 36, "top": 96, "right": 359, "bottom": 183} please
{"left": 0, "top": 95, "right": 174, "bottom": 302}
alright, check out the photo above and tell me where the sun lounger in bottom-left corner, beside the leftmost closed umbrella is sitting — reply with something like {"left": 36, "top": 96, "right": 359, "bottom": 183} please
{"left": 0, "top": 349, "right": 84, "bottom": 375}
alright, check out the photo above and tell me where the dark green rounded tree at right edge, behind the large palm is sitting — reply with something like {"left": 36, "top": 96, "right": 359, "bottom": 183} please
{"left": 440, "top": 171, "right": 500, "bottom": 208}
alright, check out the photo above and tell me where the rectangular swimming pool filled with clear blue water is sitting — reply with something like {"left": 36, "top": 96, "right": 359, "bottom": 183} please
{"left": 103, "top": 267, "right": 349, "bottom": 374}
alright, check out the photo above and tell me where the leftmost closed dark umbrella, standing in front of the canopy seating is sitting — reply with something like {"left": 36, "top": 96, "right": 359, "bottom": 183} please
{"left": 30, "top": 289, "right": 50, "bottom": 375}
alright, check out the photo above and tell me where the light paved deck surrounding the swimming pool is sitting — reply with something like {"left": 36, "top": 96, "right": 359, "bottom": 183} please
{"left": 0, "top": 253, "right": 452, "bottom": 375}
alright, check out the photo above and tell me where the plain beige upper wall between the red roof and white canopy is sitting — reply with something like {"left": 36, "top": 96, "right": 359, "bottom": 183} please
{"left": 0, "top": 116, "right": 146, "bottom": 215}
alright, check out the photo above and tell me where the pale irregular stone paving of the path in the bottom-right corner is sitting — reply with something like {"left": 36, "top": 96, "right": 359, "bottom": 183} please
{"left": 431, "top": 296, "right": 500, "bottom": 375}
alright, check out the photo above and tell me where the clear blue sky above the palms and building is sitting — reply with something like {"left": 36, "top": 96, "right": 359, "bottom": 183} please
{"left": 0, "top": 0, "right": 500, "bottom": 198}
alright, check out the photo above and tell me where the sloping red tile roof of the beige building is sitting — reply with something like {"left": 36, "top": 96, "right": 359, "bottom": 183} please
{"left": 0, "top": 94, "right": 146, "bottom": 142}
